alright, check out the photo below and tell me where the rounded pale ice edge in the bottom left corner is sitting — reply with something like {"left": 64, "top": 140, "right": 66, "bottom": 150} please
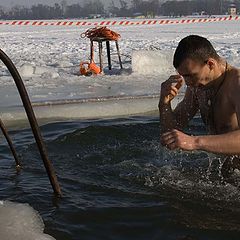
{"left": 0, "top": 201, "right": 55, "bottom": 240}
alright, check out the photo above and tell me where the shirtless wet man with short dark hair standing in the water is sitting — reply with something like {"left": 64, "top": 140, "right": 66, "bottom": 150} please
{"left": 159, "top": 35, "right": 240, "bottom": 177}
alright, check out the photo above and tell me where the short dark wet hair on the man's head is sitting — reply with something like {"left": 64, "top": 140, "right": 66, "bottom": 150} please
{"left": 173, "top": 35, "right": 220, "bottom": 69}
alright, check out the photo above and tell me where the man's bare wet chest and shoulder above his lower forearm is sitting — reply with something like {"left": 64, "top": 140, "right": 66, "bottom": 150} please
{"left": 193, "top": 64, "right": 240, "bottom": 134}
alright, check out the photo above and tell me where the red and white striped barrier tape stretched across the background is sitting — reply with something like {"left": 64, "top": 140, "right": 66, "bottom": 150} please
{"left": 0, "top": 16, "right": 240, "bottom": 26}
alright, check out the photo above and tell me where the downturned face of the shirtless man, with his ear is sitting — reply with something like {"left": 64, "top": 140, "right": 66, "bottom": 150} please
{"left": 177, "top": 58, "right": 210, "bottom": 87}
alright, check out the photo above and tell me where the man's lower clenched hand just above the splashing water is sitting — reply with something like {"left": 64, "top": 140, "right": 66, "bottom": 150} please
{"left": 161, "top": 129, "right": 197, "bottom": 151}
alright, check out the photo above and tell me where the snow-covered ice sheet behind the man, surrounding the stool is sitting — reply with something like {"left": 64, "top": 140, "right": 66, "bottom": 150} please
{"left": 0, "top": 21, "right": 240, "bottom": 123}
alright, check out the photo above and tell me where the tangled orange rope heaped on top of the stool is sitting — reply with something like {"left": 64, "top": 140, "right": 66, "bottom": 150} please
{"left": 81, "top": 27, "right": 121, "bottom": 41}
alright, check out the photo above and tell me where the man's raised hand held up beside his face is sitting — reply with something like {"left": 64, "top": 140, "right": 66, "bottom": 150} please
{"left": 160, "top": 75, "right": 184, "bottom": 104}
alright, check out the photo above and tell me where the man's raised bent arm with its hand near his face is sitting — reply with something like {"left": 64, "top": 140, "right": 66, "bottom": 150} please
{"left": 158, "top": 75, "right": 199, "bottom": 133}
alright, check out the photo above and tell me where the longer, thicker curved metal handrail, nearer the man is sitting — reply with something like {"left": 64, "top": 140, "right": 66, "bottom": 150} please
{"left": 0, "top": 49, "right": 62, "bottom": 196}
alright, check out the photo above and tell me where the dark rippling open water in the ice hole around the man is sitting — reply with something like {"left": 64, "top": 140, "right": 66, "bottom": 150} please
{"left": 0, "top": 117, "right": 240, "bottom": 240}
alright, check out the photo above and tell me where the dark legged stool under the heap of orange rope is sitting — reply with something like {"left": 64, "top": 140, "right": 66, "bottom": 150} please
{"left": 90, "top": 38, "right": 123, "bottom": 72}
